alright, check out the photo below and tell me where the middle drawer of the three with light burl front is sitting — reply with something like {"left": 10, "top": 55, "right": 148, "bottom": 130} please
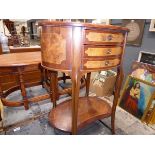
{"left": 84, "top": 46, "right": 122, "bottom": 57}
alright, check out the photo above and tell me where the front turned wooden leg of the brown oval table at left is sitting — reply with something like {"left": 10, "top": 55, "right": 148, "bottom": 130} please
{"left": 18, "top": 67, "right": 29, "bottom": 110}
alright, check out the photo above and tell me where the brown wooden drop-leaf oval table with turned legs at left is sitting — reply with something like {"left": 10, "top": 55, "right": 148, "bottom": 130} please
{"left": 0, "top": 52, "right": 49, "bottom": 109}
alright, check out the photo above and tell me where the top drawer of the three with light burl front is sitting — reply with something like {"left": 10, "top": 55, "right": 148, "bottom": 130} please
{"left": 85, "top": 30, "right": 124, "bottom": 43}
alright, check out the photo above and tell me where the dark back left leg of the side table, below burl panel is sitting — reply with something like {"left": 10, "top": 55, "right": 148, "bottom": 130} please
{"left": 50, "top": 71, "right": 59, "bottom": 108}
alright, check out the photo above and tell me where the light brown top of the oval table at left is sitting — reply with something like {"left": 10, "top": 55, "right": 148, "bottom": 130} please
{"left": 0, "top": 51, "right": 41, "bottom": 67}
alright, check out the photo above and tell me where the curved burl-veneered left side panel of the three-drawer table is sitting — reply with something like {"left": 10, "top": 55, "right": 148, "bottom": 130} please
{"left": 41, "top": 27, "right": 71, "bottom": 69}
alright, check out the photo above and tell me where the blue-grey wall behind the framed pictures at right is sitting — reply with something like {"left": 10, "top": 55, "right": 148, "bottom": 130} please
{"left": 112, "top": 19, "right": 155, "bottom": 79}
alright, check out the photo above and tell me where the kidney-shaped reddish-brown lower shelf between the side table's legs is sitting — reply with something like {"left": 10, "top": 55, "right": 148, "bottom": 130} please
{"left": 49, "top": 97, "right": 112, "bottom": 132}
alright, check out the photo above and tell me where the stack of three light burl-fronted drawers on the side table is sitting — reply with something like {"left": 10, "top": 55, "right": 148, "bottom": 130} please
{"left": 82, "top": 29, "right": 125, "bottom": 70}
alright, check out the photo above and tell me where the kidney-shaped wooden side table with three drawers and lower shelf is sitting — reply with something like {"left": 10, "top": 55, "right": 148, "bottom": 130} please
{"left": 39, "top": 21, "right": 128, "bottom": 134}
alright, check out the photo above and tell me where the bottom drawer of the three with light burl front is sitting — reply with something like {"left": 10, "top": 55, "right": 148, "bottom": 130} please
{"left": 83, "top": 58, "right": 120, "bottom": 69}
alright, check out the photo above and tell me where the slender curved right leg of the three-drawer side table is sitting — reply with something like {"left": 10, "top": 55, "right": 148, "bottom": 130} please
{"left": 111, "top": 67, "right": 123, "bottom": 134}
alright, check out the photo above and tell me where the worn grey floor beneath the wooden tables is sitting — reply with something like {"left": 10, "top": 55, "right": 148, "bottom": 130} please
{"left": 0, "top": 86, "right": 155, "bottom": 135}
